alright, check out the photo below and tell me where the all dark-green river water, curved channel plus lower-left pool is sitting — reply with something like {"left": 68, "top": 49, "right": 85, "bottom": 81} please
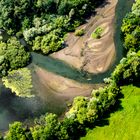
{"left": 0, "top": 0, "right": 134, "bottom": 132}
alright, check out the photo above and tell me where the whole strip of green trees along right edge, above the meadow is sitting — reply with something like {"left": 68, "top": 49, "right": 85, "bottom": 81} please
{"left": 111, "top": 0, "right": 140, "bottom": 85}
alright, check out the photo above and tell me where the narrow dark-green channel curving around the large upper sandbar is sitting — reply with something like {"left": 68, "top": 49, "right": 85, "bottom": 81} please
{"left": 32, "top": 0, "right": 135, "bottom": 84}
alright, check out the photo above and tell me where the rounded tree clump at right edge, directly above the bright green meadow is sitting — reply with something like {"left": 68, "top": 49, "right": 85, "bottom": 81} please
{"left": 111, "top": 51, "right": 140, "bottom": 85}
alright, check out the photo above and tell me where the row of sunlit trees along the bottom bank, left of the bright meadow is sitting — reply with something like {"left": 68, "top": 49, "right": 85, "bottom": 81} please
{"left": 2, "top": 81, "right": 119, "bottom": 140}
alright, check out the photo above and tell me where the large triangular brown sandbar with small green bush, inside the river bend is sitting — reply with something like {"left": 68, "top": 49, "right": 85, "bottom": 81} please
{"left": 51, "top": 0, "right": 118, "bottom": 74}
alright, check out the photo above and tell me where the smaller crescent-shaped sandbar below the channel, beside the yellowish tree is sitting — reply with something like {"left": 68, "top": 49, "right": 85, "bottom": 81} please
{"left": 33, "top": 66, "right": 100, "bottom": 101}
